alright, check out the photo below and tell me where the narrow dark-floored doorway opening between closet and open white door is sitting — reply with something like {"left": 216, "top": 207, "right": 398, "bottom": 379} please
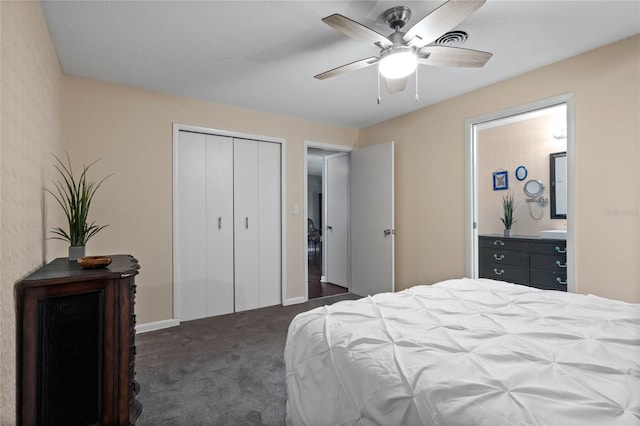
{"left": 306, "top": 146, "right": 349, "bottom": 299}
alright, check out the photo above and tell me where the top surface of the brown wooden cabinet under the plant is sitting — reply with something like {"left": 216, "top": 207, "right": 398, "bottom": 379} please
{"left": 18, "top": 254, "right": 140, "bottom": 285}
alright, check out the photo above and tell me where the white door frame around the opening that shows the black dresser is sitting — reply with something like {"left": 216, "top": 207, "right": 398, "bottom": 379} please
{"left": 465, "top": 93, "right": 577, "bottom": 293}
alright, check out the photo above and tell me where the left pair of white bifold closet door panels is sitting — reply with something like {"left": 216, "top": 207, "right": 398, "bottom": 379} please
{"left": 174, "top": 132, "right": 234, "bottom": 321}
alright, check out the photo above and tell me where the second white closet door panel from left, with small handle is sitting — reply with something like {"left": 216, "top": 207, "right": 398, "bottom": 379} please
{"left": 203, "top": 135, "right": 233, "bottom": 316}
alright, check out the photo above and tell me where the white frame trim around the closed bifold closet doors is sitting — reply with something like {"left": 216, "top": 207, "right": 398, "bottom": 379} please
{"left": 171, "top": 122, "right": 287, "bottom": 320}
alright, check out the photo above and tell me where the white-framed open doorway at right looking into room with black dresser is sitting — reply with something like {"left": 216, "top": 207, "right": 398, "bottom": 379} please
{"left": 466, "top": 95, "right": 575, "bottom": 292}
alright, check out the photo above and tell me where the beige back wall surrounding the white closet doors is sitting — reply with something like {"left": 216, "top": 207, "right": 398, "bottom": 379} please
{"left": 63, "top": 76, "right": 358, "bottom": 323}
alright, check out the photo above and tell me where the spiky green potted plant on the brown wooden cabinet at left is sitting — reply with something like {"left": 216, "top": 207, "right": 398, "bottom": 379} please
{"left": 45, "top": 153, "right": 111, "bottom": 260}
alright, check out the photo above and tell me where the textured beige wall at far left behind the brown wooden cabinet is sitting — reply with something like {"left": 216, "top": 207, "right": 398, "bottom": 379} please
{"left": 0, "top": 1, "right": 64, "bottom": 425}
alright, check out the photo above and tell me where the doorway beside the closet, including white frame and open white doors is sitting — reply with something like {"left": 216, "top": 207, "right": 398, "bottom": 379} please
{"left": 304, "top": 141, "right": 395, "bottom": 300}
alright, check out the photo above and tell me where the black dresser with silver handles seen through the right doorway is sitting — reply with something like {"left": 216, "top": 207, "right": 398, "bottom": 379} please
{"left": 478, "top": 235, "right": 567, "bottom": 291}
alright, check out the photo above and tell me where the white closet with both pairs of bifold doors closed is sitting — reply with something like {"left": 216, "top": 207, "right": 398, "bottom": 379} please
{"left": 174, "top": 130, "right": 282, "bottom": 321}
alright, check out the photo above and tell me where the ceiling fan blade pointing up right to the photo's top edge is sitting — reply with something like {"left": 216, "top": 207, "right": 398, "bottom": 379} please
{"left": 403, "top": 0, "right": 486, "bottom": 47}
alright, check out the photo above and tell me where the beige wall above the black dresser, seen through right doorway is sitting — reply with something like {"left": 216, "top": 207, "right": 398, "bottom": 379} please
{"left": 477, "top": 110, "right": 567, "bottom": 236}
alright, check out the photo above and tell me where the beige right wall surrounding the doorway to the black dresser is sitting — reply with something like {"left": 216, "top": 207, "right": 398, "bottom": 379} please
{"left": 358, "top": 35, "right": 640, "bottom": 302}
